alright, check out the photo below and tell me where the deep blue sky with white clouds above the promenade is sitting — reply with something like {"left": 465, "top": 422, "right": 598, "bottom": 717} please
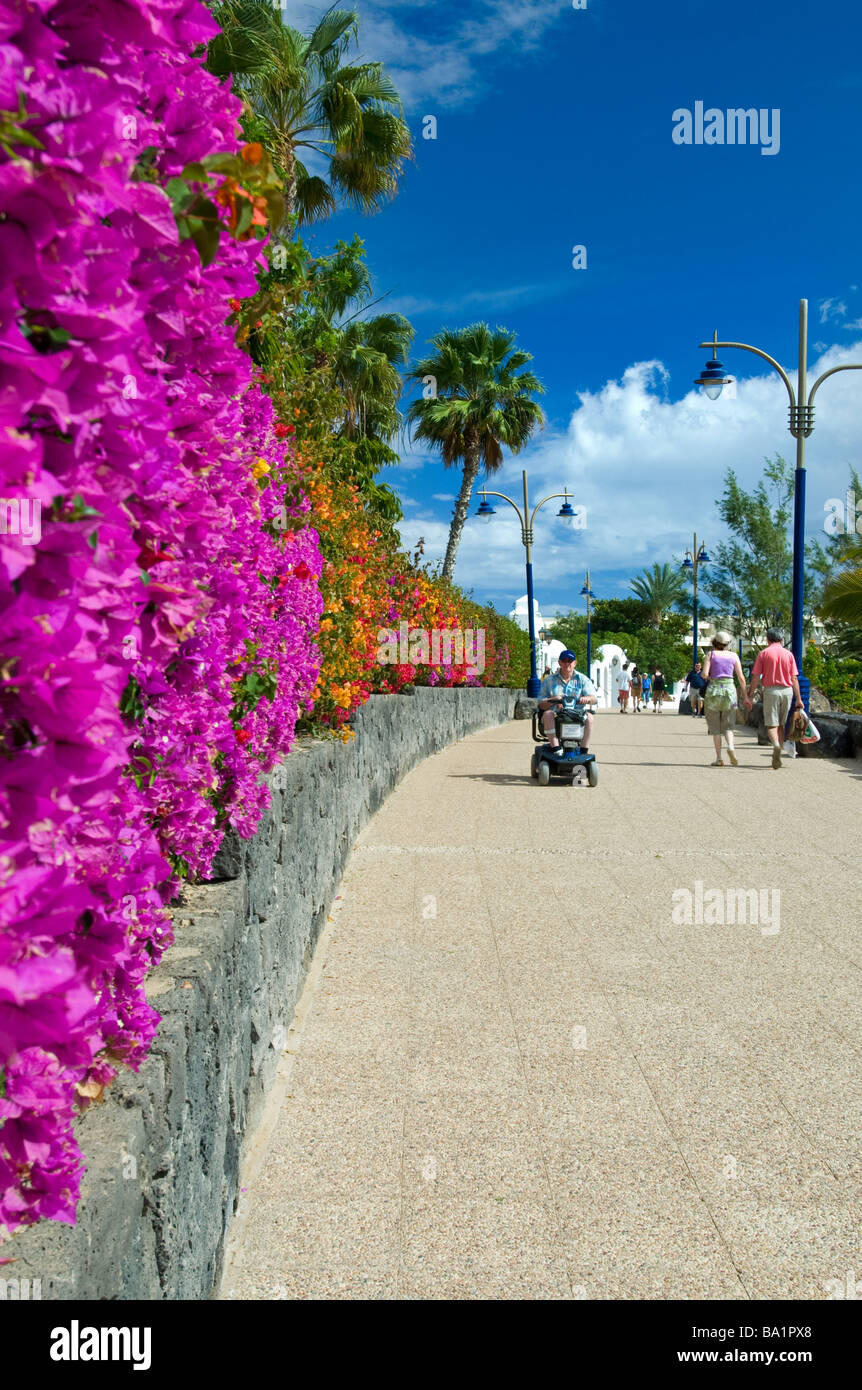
{"left": 282, "top": 0, "right": 862, "bottom": 613}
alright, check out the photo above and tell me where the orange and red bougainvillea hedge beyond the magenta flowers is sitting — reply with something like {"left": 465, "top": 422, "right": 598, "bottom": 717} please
{"left": 259, "top": 364, "right": 530, "bottom": 738}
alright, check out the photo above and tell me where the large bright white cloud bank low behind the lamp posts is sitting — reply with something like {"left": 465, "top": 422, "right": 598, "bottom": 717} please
{"left": 402, "top": 342, "right": 862, "bottom": 609}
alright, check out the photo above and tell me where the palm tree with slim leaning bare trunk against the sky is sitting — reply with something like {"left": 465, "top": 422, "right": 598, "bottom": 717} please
{"left": 407, "top": 324, "right": 545, "bottom": 580}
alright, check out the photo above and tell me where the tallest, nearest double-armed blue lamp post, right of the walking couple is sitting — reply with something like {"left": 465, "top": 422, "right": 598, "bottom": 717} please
{"left": 695, "top": 299, "right": 862, "bottom": 709}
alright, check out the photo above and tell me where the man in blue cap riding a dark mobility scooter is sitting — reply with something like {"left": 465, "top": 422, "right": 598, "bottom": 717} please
{"left": 530, "top": 652, "right": 599, "bottom": 787}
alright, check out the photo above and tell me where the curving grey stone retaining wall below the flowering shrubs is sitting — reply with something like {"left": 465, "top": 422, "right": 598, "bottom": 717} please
{"left": 0, "top": 688, "right": 519, "bottom": 1300}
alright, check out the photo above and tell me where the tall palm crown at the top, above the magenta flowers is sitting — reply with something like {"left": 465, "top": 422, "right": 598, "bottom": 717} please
{"left": 206, "top": 0, "right": 412, "bottom": 224}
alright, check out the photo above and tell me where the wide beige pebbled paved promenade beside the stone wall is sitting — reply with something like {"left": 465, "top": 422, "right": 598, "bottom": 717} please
{"left": 221, "top": 712, "right": 862, "bottom": 1300}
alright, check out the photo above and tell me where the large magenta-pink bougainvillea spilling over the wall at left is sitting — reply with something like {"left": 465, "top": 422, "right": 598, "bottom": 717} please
{"left": 0, "top": 0, "right": 321, "bottom": 1232}
